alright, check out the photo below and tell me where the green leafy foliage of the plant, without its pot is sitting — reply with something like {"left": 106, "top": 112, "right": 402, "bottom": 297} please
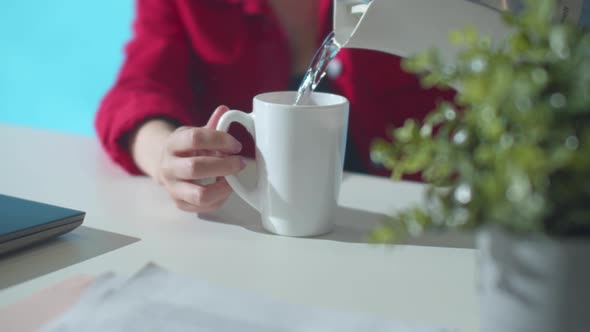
{"left": 372, "top": 0, "right": 590, "bottom": 242}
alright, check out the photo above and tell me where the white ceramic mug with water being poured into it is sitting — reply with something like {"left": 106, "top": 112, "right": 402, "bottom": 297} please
{"left": 217, "top": 92, "right": 349, "bottom": 236}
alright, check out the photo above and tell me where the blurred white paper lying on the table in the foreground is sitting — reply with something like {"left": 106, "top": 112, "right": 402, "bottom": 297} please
{"left": 42, "top": 264, "right": 450, "bottom": 332}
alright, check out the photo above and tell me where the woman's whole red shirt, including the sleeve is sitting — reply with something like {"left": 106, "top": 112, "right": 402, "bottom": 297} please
{"left": 96, "top": 0, "right": 448, "bottom": 174}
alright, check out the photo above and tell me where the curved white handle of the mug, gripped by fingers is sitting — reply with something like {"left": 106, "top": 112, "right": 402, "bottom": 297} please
{"left": 217, "top": 110, "right": 260, "bottom": 211}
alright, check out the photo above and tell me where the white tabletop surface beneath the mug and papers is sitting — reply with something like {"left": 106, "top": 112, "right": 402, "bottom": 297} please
{"left": 0, "top": 125, "right": 479, "bottom": 332}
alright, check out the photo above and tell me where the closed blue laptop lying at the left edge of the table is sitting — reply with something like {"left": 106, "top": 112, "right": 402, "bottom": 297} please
{"left": 0, "top": 195, "right": 85, "bottom": 255}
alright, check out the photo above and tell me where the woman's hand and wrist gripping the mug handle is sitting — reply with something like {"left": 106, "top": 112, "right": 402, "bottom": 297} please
{"left": 133, "top": 106, "right": 246, "bottom": 212}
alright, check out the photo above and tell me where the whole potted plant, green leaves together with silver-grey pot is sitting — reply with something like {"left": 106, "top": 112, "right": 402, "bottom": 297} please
{"left": 372, "top": 0, "right": 590, "bottom": 332}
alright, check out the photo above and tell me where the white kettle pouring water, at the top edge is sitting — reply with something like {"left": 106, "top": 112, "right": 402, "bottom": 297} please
{"left": 334, "top": 0, "right": 590, "bottom": 60}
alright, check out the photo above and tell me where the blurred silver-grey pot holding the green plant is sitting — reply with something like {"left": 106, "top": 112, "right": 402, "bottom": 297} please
{"left": 477, "top": 228, "right": 590, "bottom": 332}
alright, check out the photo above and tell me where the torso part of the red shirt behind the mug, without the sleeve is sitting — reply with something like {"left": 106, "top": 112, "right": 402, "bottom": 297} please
{"left": 177, "top": 0, "right": 450, "bottom": 173}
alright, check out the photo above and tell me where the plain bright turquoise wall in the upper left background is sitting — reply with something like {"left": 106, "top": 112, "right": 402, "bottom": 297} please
{"left": 0, "top": 0, "right": 133, "bottom": 135}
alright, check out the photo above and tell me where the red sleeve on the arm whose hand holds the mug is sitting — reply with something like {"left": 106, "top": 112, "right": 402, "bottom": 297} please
{"left": 95, "top": 0, "right": 193, "bottom": 174}
